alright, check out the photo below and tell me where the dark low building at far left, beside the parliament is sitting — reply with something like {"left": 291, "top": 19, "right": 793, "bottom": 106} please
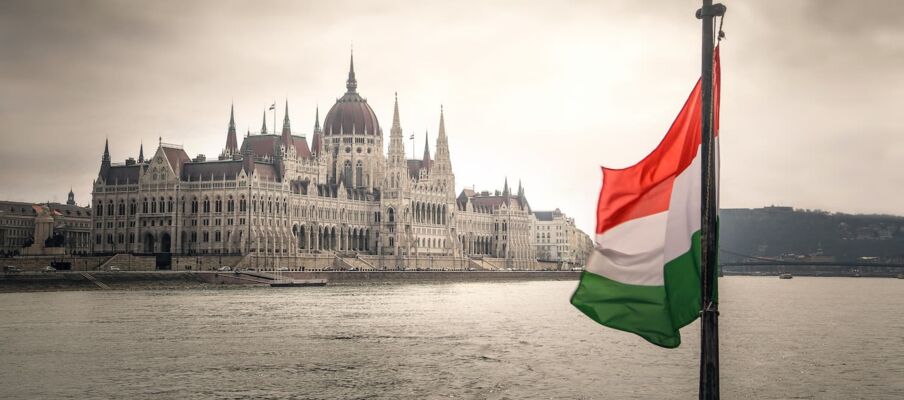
{"left": 0, "top": 190, "right": 91, "bottom": 255}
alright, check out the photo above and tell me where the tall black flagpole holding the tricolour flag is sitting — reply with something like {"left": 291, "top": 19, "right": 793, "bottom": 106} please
{"left": 697, "top": 0, "right": 725, "bottom": 400}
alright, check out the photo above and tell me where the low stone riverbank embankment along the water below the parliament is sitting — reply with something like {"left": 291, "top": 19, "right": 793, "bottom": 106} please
{"left": 0, "top": 271, "right": 580, "bottom": 293}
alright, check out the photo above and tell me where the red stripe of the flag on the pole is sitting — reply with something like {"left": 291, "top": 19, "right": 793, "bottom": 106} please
{"left": 596, "top": 47, "right": 721, "bottom": 234}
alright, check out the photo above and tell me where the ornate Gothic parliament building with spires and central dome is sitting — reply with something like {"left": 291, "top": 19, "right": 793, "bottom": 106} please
{"left": 92, "top": 52, "right": 584, "bottom": 266}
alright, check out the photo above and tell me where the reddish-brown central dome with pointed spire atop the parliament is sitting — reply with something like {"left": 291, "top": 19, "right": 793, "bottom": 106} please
{"left": 323, "top": 56, "right": 382, "bottom": 136}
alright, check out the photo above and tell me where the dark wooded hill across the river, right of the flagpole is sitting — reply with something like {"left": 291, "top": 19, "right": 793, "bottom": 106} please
{"left": 719, "top": 207, "right": 904, "bottom": 261}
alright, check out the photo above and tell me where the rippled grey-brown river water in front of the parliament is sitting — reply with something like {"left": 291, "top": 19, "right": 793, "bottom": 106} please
{"left": 0, "top": 277, "right": 904, "bottom": 399}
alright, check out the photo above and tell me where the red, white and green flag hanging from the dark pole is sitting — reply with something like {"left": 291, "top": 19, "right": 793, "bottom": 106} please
{"left": 571, "top": 47, "right": 720, "bottom": 348}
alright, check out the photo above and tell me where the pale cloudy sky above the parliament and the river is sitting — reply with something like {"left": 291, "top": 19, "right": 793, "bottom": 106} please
{"left": 0, "top": 0, "right": 904, "bottom": 232}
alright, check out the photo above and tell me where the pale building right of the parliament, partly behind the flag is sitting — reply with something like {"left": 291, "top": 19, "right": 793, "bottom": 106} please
{"left": 533, "top": 208, "right": 592, "bottom": 265}
